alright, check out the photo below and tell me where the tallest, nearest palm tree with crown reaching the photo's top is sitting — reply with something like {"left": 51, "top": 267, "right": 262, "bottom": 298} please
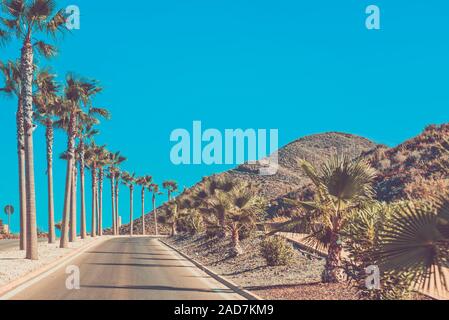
{"left": 0, "top": 0, "right": 65, "bottom": 260}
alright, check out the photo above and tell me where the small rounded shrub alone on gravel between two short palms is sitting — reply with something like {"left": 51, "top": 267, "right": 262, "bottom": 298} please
{"left": 260, "top": 236, "right": 294, "bottom": 266}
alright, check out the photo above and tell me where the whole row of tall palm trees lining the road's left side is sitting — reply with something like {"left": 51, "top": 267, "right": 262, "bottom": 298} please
{"left": 0, "top": 0, "right": 182, "bottom": 260}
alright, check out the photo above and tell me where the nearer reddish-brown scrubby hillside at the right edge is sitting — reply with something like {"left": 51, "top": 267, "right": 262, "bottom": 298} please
{"left": 363, "top": 124, "right": 449, "bottom": 201}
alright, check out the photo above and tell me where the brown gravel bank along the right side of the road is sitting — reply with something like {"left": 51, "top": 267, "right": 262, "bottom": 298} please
{"left": 164, "top": 235, "right": 364, "bottom": 300}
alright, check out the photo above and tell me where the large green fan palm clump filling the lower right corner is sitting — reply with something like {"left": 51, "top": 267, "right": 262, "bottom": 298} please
{"left": 345, "top": 197, "right": 449, "bottom": 299}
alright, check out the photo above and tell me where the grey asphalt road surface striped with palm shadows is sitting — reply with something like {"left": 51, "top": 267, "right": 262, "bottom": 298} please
{"left": 6, "top": 237, "right": 243, "bottom": 300}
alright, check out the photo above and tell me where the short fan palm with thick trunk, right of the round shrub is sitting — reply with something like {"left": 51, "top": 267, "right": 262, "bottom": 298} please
{"left": 270, "top": 156, "right": 376, "bottom": 282}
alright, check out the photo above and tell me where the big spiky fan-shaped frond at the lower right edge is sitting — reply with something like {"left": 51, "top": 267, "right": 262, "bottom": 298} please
{"left": 379, "top": 204, "right": 449, "bottom": 290}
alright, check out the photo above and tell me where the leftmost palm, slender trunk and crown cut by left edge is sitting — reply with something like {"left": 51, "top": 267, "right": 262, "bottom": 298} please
{"left": 0, "top": 59, "right": 27, "bottom": 250}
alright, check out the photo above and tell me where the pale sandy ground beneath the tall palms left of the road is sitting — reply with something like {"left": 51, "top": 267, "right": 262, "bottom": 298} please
{"left": 0, "top": 238, "right": 99, "bottom": 286}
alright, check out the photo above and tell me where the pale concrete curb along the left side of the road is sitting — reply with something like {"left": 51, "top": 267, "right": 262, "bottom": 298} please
{"left": 0, "top": 238, "right": 112, "bottom": 300}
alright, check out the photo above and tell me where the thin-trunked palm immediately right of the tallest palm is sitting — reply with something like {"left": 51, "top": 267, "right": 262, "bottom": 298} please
{"left": 34, "top": 70, "right": 60, "bottom": 243}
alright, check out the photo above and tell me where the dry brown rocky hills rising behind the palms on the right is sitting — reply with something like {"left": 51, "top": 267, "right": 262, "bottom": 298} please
{"left": 122, "top": 124, "right": 449, "bottom": 233}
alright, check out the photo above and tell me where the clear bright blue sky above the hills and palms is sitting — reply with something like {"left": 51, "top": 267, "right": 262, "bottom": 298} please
{"left": 0, "top": 0, "right": 449, "bottom": 230}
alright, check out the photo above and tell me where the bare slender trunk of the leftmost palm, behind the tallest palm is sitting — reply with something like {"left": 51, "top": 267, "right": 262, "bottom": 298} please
{"left": 16, "top": 97, "right": 27, "bottom": 250}
